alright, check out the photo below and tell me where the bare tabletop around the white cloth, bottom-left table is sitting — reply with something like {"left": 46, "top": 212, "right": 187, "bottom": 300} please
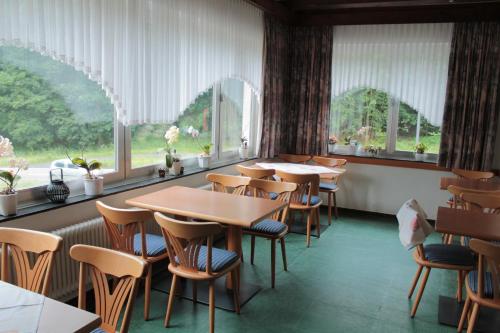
{"left": 0, "top": 281, "right": 101, "bottom": 333}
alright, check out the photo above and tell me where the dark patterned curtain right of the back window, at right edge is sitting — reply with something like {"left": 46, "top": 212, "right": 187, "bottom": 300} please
{"left": 438, "top": 22, "right": 500, "bottom": 170}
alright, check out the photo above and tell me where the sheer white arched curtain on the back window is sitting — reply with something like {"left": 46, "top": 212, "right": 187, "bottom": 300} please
{"left": 332, "top": 23, "right": 453, "bottom": 126}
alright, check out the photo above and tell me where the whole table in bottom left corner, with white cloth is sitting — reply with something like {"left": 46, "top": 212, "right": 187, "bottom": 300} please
{"left": 0, "top": 281, "right": 101, "bottom": 333}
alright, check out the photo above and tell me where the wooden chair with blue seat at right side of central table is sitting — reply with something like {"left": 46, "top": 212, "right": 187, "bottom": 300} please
{"left": 243, "top": 179, "right": 297, "bottom": 288}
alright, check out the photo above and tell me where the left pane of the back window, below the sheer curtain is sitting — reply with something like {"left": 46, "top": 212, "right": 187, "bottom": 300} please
{"left": 330, "top": 89, "right": 389, "bottom": 147}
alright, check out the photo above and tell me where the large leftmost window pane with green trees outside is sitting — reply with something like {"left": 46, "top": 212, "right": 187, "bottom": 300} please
{"left": 0, "top": 46, "right": 115, "bottom": 189}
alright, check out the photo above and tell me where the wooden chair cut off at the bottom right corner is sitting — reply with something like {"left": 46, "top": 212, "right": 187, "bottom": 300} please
{"left": 458, "top": 239, "right": 500, "bottom": 333}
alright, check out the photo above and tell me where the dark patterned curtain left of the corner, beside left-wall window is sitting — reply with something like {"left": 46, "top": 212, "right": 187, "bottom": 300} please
{"left": 260, "top": 14, "right": 290, "bottom": 158}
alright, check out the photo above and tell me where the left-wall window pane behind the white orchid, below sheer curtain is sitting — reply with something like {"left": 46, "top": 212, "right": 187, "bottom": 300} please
{"left": 130, "top": 89, "right": 213, "bottom": 169}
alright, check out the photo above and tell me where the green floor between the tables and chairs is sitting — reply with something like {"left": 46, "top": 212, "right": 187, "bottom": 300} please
{"left": 130, "top": 211, "right": 456, "bottom": 333}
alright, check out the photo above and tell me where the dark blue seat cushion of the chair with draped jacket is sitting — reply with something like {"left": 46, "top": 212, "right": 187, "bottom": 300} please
{"left": 424, "top": 244, "right": 474, "bottom": 266}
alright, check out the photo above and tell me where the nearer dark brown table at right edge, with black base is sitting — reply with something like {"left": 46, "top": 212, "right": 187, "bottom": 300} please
{"left": 435, "top": 207, "right": 500, "bottom": 332}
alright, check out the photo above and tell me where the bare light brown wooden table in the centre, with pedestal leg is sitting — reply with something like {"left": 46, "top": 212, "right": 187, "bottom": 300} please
{"left": 126, "top": 186, "right": 287, "bottom": 310}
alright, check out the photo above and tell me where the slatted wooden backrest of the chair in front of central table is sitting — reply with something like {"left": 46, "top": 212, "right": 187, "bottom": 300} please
{"left": 155, "top": 213, "right": 223, "bottom": 275}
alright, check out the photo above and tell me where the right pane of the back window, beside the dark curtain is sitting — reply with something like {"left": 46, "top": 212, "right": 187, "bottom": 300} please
{"left": 396, "top": 103, "right": 441, "bottom": 154}
